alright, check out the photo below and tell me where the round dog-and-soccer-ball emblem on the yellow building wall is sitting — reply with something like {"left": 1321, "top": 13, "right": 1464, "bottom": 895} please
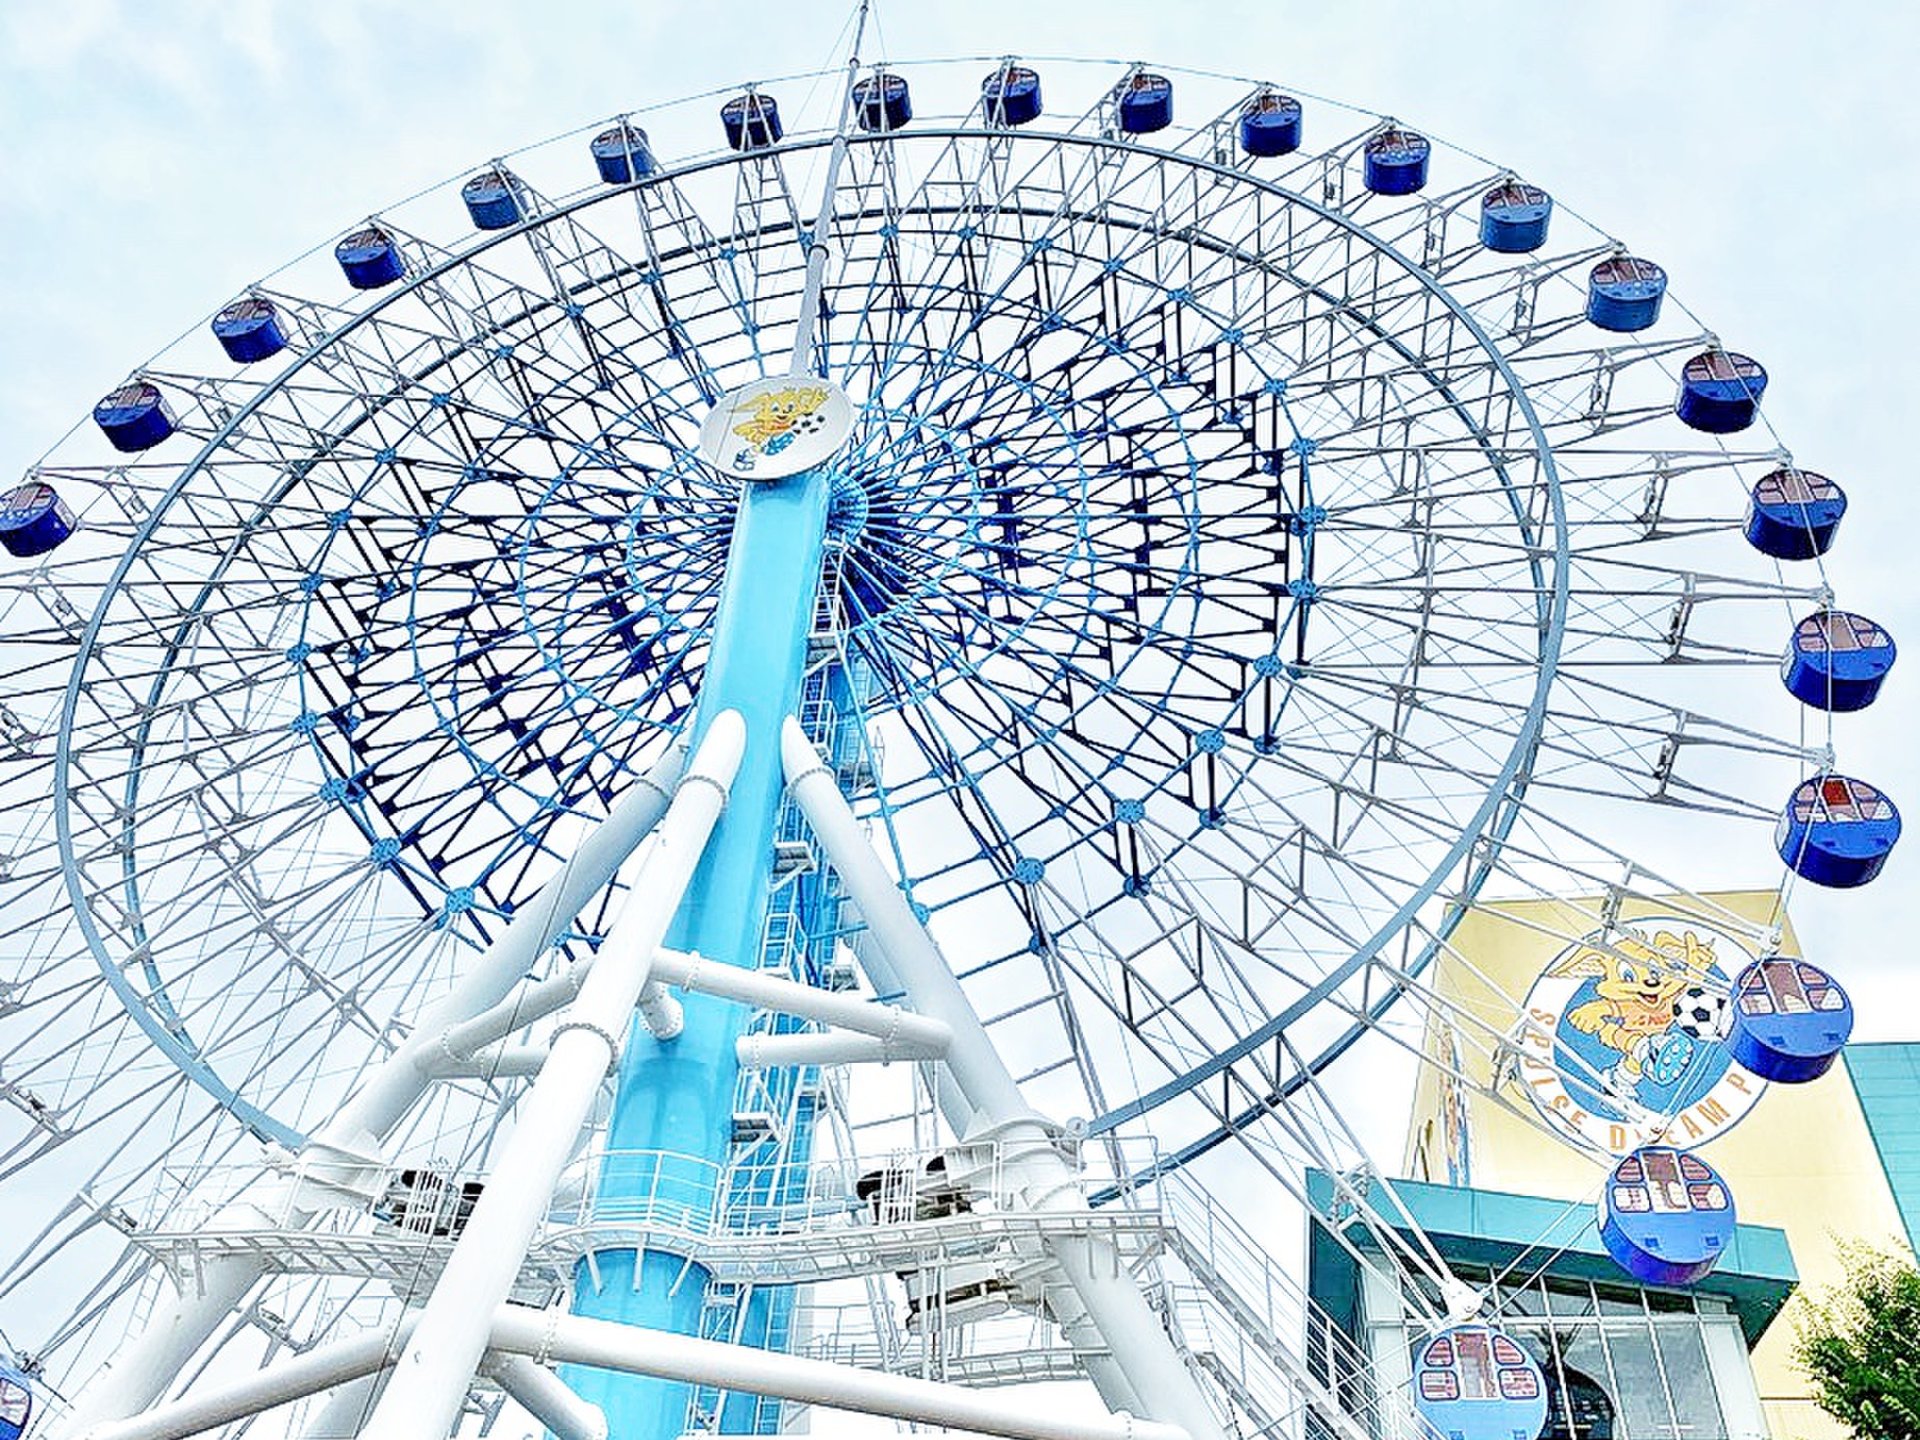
{"left": 1515, "top": 916, "right": 1764, "bottom": 1154}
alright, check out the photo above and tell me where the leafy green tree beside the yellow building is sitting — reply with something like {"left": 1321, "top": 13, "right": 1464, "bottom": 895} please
{"left": 1795, "top": 1244, "right": 1920, "bottom": 1440}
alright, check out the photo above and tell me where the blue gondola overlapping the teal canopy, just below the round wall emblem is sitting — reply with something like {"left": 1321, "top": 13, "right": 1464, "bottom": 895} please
{"left": 1599, "top": 1144, "right": 1734, "bottom": 1284}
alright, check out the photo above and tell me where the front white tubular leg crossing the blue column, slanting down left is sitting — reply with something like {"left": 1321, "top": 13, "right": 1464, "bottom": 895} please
{"left": 361, "top": 710, "right": 747, "bottom": 1440}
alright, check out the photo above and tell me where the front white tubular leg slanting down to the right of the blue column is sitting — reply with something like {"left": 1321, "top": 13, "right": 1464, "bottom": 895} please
{"left": 781, "top": 718, "right": 1223, "bottom": 1440}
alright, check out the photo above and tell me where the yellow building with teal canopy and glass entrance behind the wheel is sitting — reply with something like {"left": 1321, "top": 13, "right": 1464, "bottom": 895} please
{"left": 1309, "top": 891, "right": 1920, "bottom": 1440}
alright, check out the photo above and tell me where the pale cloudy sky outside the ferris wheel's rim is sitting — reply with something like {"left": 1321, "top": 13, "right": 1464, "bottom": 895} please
{"left": 0, "top": 0, "right": 1920, "bottom": 1039}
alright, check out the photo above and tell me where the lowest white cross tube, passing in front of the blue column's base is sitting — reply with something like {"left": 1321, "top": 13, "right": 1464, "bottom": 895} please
{"left": 495, "top": 1306, "right": 1190, "bottom": 1440}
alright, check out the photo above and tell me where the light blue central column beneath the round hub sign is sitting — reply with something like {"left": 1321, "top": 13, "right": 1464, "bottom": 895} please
{"left": 566, "top": 467, "right": 831, "bottom": 1440}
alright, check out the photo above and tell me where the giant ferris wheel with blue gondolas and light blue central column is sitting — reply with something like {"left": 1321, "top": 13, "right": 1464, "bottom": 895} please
{"left": 0, "top": 30, "right": 1899, "bottom": 1440}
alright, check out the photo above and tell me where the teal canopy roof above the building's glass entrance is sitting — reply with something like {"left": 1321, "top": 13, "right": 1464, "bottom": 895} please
{"left": 1308, "top": 1154, "right": 1797, "bottom": 1346}
